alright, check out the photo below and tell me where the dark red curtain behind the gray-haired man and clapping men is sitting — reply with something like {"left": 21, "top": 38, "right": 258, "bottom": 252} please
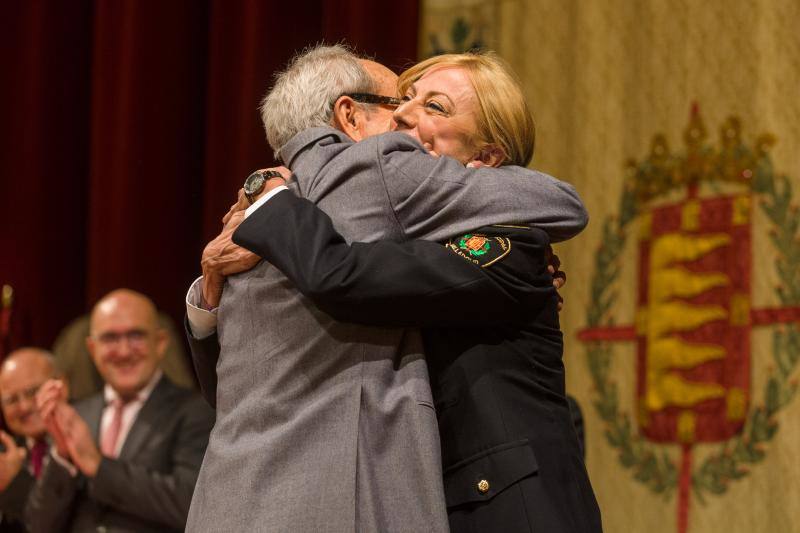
{"left": 0, "top": 0, "right": 418, "bottom": 354}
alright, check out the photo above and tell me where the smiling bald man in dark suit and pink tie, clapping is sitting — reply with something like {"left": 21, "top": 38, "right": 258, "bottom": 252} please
{"left": 26, "top": 289, "right": 214, "bottom": 532}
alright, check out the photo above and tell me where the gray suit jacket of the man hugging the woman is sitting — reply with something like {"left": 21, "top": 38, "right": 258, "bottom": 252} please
{"left": 187, "top": 128, "right": 586, "bottom": 532}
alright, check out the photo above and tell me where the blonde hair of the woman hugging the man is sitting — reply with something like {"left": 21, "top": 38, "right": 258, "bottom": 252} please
{"left": 397, "top": 52, "right": 536, "bottom": 167}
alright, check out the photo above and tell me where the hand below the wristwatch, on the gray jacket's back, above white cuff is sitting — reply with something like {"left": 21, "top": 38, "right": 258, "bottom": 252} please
{"left": 200, "top": 207, "right": 261, "bottom": 308}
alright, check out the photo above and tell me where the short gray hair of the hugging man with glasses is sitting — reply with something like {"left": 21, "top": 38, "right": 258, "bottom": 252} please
{"left": 261, "top": 44, "right": 376, "bottom": 157}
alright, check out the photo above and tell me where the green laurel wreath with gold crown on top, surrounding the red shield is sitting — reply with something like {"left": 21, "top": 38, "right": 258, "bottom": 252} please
{"left": 586, "top": 114, "right": 800, "bottom": 502}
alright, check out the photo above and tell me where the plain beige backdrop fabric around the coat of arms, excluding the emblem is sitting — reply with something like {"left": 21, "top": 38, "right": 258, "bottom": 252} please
{"left": 421, "top": 0, "right": 800, "bottom": 533}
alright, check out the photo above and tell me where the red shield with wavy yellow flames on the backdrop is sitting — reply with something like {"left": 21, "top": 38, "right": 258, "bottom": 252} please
{"left": 637, "top": 196, "right": 751, "bottom": 444}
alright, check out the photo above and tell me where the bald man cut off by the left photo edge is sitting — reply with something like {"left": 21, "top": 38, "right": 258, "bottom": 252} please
{"left": 0, "top": 348, "right": 61, "bottom": 531}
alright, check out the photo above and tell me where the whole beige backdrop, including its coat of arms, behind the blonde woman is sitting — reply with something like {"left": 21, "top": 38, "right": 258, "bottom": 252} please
{"left": 420, "top": 0, "right": 800, "bottom": 533}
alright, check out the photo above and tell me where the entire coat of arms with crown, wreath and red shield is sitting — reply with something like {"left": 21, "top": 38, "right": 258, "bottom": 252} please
{"left": 579, "top": 106, "right": 800, "bottom": 533}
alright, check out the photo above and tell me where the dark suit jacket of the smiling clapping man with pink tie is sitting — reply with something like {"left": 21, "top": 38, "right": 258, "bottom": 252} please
{"left": 26, "top": 377, "right": 214, "bottom": 533}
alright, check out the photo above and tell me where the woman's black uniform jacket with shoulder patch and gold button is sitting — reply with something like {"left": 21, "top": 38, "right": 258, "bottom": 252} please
{"left": 225, "top": 193, "right": 601, "bottom": 532}
